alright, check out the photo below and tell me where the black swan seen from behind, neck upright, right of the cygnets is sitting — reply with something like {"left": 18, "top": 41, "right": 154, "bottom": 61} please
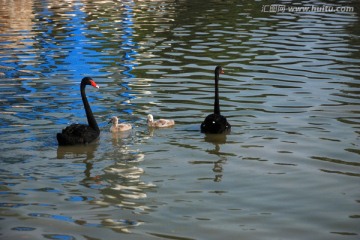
{"left": 201, "top": 66, "right": 231, "bottom": 133}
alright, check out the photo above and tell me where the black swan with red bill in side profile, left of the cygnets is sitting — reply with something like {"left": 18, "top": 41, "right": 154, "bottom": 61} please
{"left": 56, "top": 77, "right": 100, "bottom": 146}
